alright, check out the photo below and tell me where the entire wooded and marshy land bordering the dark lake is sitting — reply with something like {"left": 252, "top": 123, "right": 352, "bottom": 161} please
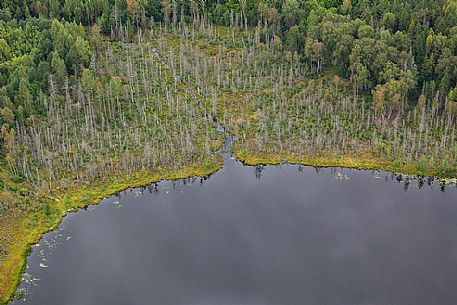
{"left": 0, "top": 0, "right": 457, "bottom": 303}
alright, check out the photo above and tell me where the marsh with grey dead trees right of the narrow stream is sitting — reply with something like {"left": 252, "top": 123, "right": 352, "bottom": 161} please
{"left": 155, "top": 25, "right": 457, "bottom": 178}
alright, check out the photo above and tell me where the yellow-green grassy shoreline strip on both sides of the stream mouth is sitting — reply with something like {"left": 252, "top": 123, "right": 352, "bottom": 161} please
{"left": 0, "top": 145, "right": 457, "bottom": 305}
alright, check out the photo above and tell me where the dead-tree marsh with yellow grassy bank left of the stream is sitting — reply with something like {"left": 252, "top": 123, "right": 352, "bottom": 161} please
{"left": 0, "top": 30, "right": 223, "bottom": 302}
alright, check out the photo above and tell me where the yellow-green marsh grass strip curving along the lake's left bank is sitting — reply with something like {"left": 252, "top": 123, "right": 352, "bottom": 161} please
{"left": 0, "top": 157, "right": 222, "bottom": 304}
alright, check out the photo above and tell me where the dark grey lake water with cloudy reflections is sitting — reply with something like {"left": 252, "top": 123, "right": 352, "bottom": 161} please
{"left": 9, "top": 160, "right": 457, "bottom": 305}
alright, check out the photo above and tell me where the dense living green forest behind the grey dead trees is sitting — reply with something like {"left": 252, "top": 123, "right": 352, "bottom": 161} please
{"left": 0, "top": 0, "right": 457, "bottom": 107}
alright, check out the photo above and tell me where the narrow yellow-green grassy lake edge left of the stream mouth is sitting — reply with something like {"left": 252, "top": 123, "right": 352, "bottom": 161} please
{"left": 0, "top": 156, "right": 223, "bottom": 305}
